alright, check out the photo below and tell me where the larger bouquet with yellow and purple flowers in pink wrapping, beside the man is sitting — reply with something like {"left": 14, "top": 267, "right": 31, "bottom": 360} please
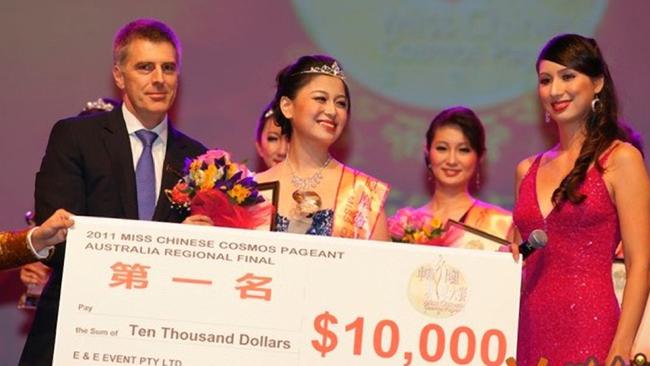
{"left": 165, "top": 150, "right": 273, "bottom": 229}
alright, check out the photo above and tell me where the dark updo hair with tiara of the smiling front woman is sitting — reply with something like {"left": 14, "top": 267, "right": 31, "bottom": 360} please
{"left": 272, "top": 55, "right": 352, "bottom": 138}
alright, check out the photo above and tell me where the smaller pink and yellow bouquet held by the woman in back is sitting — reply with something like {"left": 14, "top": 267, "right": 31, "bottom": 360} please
{"left": 388, "top": 207, "right": 454, "bottom": 246}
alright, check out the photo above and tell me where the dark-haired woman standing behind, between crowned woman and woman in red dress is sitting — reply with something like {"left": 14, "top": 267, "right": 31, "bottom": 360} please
{"left": 389, "top": 107, "right": 512, "bottom": 240}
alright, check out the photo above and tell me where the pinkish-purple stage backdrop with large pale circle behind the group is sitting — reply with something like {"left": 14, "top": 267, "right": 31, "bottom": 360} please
{"left": 0, "top": 0, "right": 650, "bottom": 365}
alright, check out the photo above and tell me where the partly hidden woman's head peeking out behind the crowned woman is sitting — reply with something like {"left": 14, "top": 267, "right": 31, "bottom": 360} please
{"left": 255, "top": 103, "right": 289, "bottom": 171}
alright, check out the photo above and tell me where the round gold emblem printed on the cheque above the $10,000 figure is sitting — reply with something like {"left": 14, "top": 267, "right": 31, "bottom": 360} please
{"left": 408, "top": 256, "right": 468, "bottom": 318}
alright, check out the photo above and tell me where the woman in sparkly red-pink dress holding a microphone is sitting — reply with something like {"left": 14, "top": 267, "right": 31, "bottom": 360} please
{"left": 513, "top": 34, "right": 650, "bottom": 365}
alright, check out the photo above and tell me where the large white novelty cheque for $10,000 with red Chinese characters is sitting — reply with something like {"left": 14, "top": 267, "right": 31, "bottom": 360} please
{"left": 54, "top": 217, "right": 521, "bottom": 366}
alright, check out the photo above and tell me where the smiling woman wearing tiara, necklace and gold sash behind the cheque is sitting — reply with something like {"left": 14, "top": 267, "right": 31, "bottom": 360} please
{"left": 252, "top": 55, "right": 389, "bottom": 240}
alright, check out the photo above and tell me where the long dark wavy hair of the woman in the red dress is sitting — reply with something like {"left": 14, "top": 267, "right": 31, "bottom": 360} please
{"left": 536, "top": 34, "right": 629, "bottom": 205}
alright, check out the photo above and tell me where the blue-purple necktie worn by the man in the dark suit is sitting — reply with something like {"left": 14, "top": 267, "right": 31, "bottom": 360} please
{"left": 135, "top": 130, "right": 158, "bottom": 220}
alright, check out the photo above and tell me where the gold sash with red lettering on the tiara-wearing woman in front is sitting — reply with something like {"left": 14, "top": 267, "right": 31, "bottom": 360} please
{"left": 332, "top": 166, "right": 390, "bottom": 239}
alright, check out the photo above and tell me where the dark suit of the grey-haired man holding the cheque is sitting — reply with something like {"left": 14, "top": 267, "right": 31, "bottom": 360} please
{"left": 19, "top": 108, "right": 205, "bottom": 366}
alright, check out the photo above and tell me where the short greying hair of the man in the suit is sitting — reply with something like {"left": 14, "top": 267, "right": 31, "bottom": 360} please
{"left": 113, "top": 19, "right": 181, "bottom": 65}
